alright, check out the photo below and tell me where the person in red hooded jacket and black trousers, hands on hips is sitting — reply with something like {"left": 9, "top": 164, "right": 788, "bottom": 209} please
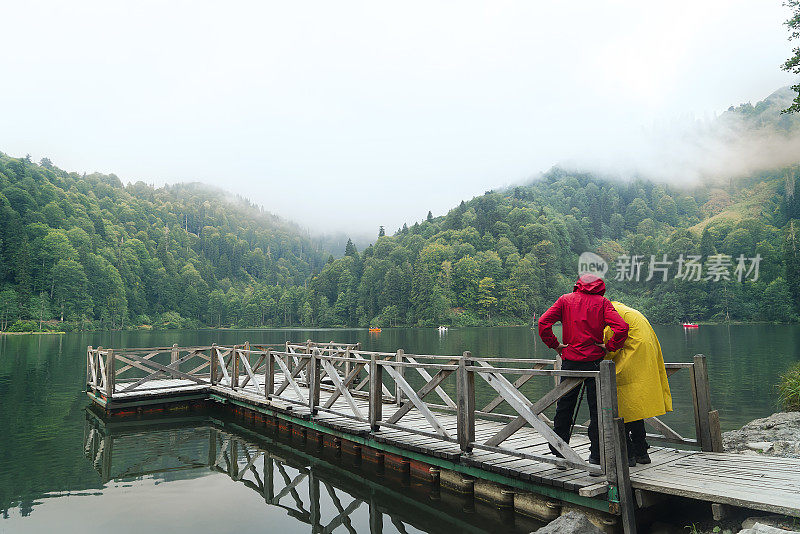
{"left": 539, "top": 274, "right": 628, "bottom": 464}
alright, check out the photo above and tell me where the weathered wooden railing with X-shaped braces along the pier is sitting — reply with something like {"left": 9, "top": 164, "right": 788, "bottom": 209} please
{"left": 87, "top": 341, "right": 721, "bottom": 528}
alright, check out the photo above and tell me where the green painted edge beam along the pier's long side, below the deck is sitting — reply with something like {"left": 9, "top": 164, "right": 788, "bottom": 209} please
{"left": 209, "top": 393, "right": 616, "bottom": 515}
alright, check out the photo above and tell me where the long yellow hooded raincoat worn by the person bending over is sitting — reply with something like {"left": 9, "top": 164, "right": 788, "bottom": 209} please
{"left": 603, "top": 301, "right": 672, "bottom": 423}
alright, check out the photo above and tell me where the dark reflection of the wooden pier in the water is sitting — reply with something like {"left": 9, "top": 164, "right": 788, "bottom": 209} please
{"left": 84, "top": 409, "right": 541, "bottom": 534}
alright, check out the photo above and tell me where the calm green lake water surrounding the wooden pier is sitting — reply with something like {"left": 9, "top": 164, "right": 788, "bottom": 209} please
{"left": 0, "top": 325, "right": 800, "bottom": 534}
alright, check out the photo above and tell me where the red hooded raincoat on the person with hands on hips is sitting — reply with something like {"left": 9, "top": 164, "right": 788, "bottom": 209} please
{"left": 539, "top": 274, "right": 628, "bottom": 362}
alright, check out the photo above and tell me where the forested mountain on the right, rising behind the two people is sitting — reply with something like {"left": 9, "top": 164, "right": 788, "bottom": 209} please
{"left": 304, "top": 88, "right": 800, "bottom": 326}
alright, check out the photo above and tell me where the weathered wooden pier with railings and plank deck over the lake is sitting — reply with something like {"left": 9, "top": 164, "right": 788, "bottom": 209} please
{"left": 86, "top": 341, "right": 800, "bottom": 532}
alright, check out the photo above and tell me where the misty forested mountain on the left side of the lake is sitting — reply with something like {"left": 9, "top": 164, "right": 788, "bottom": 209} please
{"left": 0, "top": 154, "right": 329, "bottom": 330}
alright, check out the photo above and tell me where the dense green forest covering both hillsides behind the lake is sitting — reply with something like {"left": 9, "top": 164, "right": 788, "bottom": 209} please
{"left": 0, "top": 90, "right": 800, "bottom": 331}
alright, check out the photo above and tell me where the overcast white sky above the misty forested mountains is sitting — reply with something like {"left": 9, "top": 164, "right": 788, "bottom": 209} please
{"left": 0, "top": 0, "right": 792, "bottom": 234}
